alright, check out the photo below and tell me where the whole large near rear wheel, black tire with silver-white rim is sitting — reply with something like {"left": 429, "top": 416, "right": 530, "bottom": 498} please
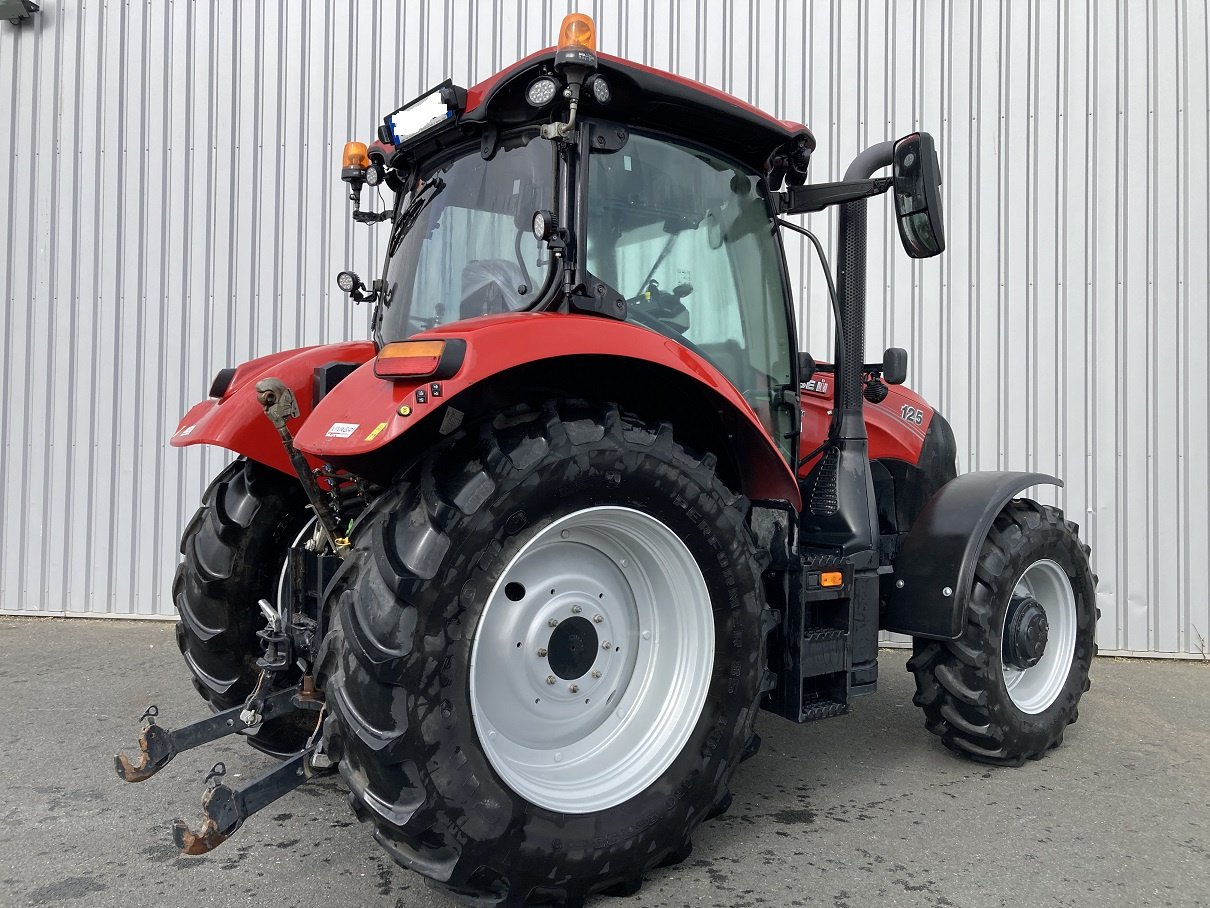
{"left": 321, "top": 403, "right": 772, "bottom": 904}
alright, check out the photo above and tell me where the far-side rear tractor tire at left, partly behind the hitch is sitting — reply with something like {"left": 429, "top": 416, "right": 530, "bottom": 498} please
{"left": 172, "top": 458, "right": 315, "bottom": 757}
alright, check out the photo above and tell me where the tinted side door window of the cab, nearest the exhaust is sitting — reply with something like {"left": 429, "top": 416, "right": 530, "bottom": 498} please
{"left": 587, "top": 133, "right": 797, "bottom": 458}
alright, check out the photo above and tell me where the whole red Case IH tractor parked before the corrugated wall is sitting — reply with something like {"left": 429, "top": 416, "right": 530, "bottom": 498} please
{"left": 117, "top": 15, "right": 1096, "bottom": 904}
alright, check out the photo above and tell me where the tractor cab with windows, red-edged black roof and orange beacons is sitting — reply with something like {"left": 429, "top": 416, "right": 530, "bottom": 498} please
{"left": 339, "top": 15, "right": 944, "bottom": 484}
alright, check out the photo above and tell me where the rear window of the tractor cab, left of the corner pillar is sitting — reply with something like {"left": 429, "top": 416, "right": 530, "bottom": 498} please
{"left": 378, "top": 133, "right": 555, "bottom": 343}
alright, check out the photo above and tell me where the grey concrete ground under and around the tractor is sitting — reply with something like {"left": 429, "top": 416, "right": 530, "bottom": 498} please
{"left": 0, "top": 619, "right": 1210, "bottom": 908}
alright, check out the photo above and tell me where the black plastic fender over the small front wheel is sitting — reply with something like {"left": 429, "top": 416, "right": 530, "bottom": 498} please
{"left": 882, "top": 472, "right": 1062, "bottom": 640}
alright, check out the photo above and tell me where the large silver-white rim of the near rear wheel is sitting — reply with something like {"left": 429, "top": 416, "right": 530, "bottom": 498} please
{"left": 469, "top": 506, "right": 714, "bottom": 814}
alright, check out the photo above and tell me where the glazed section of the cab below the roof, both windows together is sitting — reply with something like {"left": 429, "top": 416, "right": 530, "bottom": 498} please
{"left": 360, "top": 115, "right": 796, "bottom": 460}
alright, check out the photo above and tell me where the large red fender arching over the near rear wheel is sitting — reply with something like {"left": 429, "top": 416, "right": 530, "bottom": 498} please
{"left": 295, "top": 312, "right": 800, "bottom": 507}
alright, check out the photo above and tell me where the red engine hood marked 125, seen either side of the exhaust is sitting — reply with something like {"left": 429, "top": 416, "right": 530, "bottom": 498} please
{"left": 799, "top": 373, "right": 933, "bottom": 476}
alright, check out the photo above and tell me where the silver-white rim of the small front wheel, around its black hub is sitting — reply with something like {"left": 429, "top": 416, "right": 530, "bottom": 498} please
{"left": 1001, "top": 558, "right": 1076, "bottom": 714}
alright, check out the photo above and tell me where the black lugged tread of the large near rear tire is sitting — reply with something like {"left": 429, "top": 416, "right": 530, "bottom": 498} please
{"left": 317, "top": 401, "right": 776, "bottom": 906}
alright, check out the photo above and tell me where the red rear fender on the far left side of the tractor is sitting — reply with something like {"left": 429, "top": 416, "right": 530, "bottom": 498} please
{"left": 169, "top": 340, "right": 374, "bottom": 476}
